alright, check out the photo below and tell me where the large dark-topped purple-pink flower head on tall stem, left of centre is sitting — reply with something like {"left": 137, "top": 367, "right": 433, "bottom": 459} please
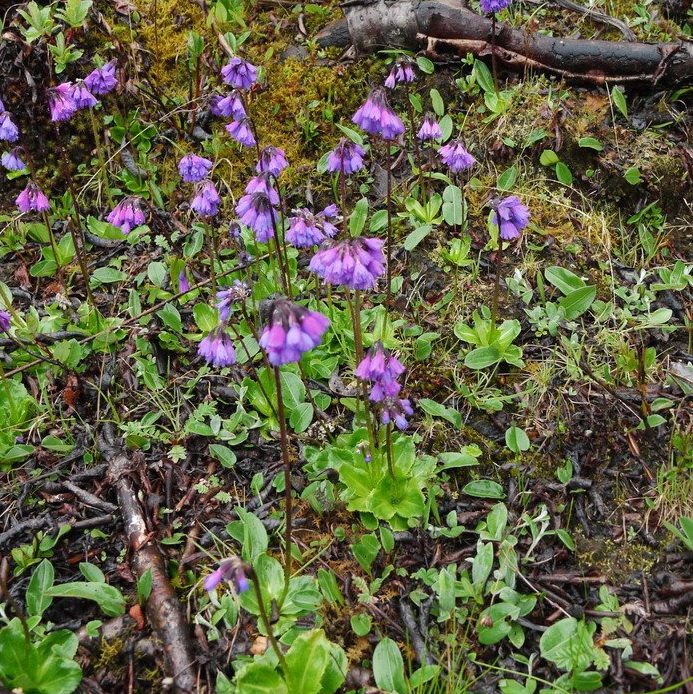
{"left": 259, "top": 299, "right": 330, "bottom": 366}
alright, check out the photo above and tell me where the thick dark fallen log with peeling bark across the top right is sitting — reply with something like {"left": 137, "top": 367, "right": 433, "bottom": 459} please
{"left": 317, "top": 0, "right": 693, "bottom": 86}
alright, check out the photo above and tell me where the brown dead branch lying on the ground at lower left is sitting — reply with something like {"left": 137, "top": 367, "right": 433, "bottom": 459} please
{"left": 100, "top": 428, "right": 196, "bottom": 693}
